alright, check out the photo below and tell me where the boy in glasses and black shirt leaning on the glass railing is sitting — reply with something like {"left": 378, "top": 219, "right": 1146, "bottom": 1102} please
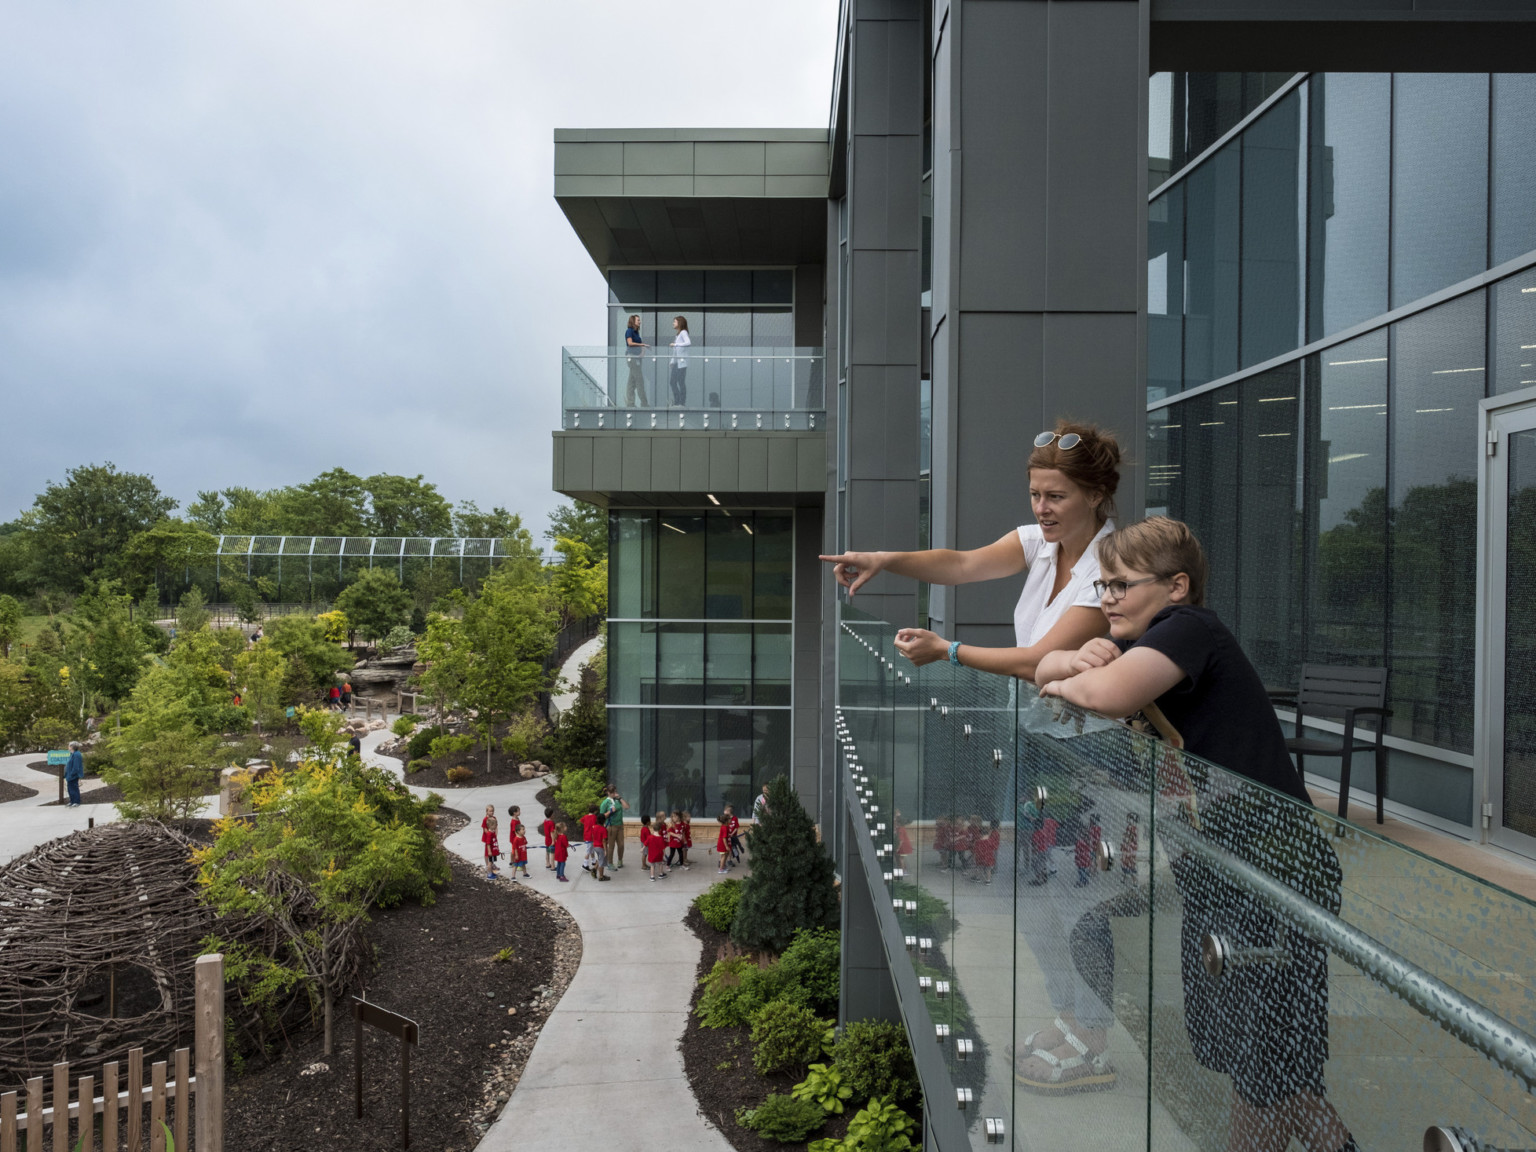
{"left": 1035, "top": 516, "right": 1356, "bottom": 1152}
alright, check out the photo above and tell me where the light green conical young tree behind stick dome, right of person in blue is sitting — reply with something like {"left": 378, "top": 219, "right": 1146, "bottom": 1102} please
{"left": 101, "top": 667, "right": 223, "bottom": 820}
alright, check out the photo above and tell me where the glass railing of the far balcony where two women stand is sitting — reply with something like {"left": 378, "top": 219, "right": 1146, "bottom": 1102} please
{"left": 561, "top": 344, "right": 826, "bottom": 432}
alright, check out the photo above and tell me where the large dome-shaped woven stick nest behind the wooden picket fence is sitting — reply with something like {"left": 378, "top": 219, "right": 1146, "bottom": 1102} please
{"left": 0, "top": 820, "right": 361, "bottom": 1089}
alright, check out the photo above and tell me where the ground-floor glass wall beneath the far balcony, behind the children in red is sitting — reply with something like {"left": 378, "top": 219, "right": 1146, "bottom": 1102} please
{"left": 608, "top": 508, "right": 794, "bottom": 816}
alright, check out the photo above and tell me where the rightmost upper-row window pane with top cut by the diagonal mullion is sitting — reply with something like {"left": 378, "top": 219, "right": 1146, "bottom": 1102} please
{"left": 1241, "top": 91, "right": 1306, "bottom": 367}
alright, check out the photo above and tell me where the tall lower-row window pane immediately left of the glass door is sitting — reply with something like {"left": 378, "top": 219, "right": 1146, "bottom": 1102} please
{"left": 1389, "top": 292, "right": 1485, "bottom": 753}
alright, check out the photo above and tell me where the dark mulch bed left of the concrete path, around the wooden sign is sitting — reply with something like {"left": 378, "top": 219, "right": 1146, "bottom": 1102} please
{"left": 224, "top": 809, "right": 582, "bottom": 1152}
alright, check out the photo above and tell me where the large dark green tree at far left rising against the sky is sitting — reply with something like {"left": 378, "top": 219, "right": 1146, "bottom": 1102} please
{"left": 32, "top": 464, "right": 177, "bottom": 591}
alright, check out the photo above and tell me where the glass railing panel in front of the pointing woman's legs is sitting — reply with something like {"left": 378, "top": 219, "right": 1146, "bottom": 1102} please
{"left": 1005, "top": 703, "right": 1150, "bottom": 1152}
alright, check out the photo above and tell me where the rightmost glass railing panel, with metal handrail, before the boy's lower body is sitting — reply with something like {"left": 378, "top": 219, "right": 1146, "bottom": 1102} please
{"left": 1150, "top": 734, "right": 1536, "bottom": 1149}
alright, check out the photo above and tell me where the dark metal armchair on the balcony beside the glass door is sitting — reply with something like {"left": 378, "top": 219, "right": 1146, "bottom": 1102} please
{"left": 1270, "top": 664, "right": 1392, "bottom": 823}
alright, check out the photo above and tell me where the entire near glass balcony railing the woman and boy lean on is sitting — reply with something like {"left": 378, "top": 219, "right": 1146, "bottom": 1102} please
{"left": 837, "top": 607, "right": 1536, "bottom": 1152}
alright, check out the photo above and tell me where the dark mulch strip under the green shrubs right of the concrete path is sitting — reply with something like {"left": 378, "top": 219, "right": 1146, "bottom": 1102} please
{"left": 679, "top": 906, "right": 857, "bottom": 1152}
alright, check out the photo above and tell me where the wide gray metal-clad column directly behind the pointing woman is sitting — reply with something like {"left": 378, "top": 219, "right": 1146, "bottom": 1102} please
{"left": 927, "top": 0, "right": 1149, "bottom": 644}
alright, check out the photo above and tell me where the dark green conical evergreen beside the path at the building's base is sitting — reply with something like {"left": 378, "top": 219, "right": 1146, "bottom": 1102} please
{"left": 731, "top": 776, "right": 839, "bottom": 952}
